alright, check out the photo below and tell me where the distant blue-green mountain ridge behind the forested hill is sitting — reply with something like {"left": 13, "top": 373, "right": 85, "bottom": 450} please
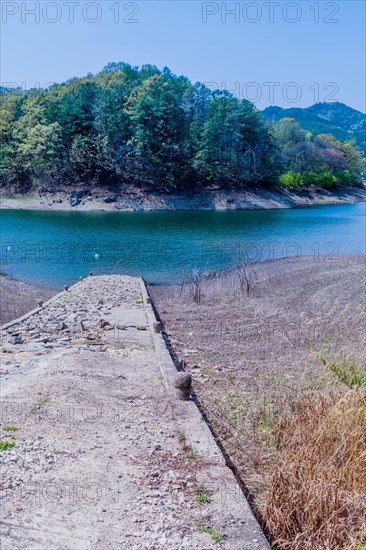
{"left": 262, "top": 103, "right": 366, "bottom": 153}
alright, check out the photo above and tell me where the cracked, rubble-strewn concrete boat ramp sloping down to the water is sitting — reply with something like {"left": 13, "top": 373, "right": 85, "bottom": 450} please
{"left": 0, "top": 275, "right": 269, "bottom": 550}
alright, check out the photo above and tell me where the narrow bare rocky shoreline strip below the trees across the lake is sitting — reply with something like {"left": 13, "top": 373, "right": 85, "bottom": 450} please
{"left": 0, "top": 185, "right": 366, "bottom": 212}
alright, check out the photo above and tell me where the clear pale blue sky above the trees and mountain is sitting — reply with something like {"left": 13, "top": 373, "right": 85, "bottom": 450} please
{"left": 1, "top": 0, "right": 366, "bottom": 112}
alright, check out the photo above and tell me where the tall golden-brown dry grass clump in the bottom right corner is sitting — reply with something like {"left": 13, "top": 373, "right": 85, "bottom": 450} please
{"left": 264, "top": 390, "right": 366, "bottom": 550}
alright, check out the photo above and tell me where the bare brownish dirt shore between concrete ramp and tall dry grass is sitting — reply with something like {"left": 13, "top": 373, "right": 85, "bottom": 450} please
{"left": 149, "top": 255, "right": 366, "bottom": 520}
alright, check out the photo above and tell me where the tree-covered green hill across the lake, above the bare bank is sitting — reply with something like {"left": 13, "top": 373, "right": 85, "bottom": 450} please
{"left": 0, "top": 63, "right": 364, "bottom": 192}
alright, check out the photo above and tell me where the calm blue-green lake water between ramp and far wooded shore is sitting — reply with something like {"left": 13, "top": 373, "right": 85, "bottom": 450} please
{"left": 0, "top": 203, "right": 366, "bottom": 288}
